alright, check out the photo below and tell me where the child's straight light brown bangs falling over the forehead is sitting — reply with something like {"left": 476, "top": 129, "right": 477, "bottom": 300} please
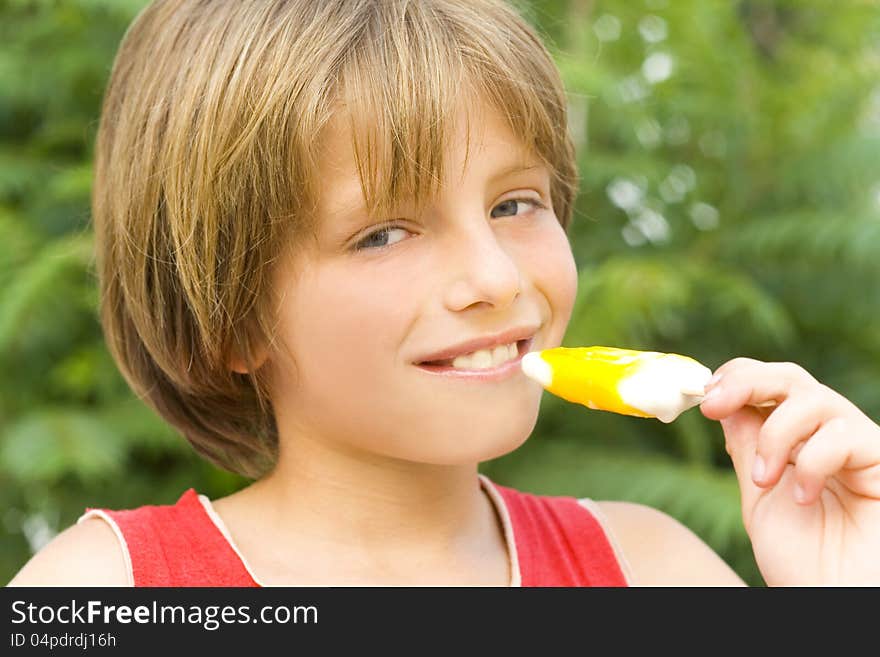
{"left": 324, "top": 2, "right": 571, "bottom": 225}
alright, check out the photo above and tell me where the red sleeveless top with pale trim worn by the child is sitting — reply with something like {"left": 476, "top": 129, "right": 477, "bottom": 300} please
{"left": 80, "top": 477, "right": 627, "bottom": 586}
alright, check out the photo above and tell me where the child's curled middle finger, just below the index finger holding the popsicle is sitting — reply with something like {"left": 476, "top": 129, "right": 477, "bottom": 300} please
{"left": 752, "top": 391, "right": 829, "bottom": 486}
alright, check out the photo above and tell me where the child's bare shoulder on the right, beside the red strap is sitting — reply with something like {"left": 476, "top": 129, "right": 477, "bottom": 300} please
{"left": 581, "top": 500, "right": 743, "bottom": 586}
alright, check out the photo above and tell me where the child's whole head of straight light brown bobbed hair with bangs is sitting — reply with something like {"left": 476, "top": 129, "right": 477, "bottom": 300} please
{"left": 92, "top": 0, "right": 578, "bottom": 477}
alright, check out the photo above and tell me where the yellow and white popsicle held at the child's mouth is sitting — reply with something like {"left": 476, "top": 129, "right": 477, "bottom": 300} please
{"left": 521, "top": 347, "right": 712, "bottom": 423}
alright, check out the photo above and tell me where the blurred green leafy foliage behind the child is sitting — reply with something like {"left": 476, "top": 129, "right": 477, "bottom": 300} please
{"left": 0, "top": 0, "right": 880, "bottom": 585}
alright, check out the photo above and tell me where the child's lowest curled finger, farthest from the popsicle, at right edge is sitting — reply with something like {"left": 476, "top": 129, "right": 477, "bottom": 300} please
{"left": 795, "top": 417, "right": 880, "bottom": 504}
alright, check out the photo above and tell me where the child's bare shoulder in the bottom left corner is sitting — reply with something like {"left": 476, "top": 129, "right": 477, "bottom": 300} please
{"left": 8, "top": 517, "right": 131, "bottom": 586}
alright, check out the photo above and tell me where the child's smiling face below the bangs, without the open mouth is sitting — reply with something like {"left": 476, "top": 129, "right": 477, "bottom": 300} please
{"left": 273, "top": 100, "right": 577, "bottom": 465}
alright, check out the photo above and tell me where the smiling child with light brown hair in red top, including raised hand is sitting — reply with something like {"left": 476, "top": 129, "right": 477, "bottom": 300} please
{"left": 12, "top": 0, "right": 880, "bottom": 586}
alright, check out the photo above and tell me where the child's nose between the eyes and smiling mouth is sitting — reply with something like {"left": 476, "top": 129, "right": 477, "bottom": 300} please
{"left": 446, "top": 222, "right": 522, "bottom": 310}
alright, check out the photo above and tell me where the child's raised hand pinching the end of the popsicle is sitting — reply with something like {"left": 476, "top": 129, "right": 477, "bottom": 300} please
{"left": 700, "top": 358, "right": 880, "bottom": 586}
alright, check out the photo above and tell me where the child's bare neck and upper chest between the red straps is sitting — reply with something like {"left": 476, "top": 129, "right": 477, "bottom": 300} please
{"left": 211, "top": 441, "right": 510, "bottom": 584}
